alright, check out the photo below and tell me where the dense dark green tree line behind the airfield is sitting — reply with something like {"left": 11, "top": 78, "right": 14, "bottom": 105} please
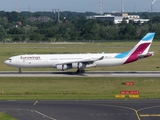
{"left": 0, "top": 11, "right": 160, "bottom": 42}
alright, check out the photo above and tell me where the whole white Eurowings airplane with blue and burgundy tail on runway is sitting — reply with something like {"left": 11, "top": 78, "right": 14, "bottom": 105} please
{"left": 4, "top": 32, "right": 155, "bottom": 74}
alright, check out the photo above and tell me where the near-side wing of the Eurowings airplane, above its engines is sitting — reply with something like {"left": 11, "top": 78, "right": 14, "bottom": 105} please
{"left": 56, "top": 56, "right": 104, "bottom": 65}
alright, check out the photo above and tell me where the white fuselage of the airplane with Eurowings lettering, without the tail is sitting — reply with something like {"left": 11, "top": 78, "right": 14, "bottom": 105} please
{"left": 5, "top": 53, "right": 126, "bottom": 68}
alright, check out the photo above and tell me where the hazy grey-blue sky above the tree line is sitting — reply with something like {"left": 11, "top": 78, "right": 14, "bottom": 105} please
{"left": 0, "top": 0, "right": 160, "bottom": 13}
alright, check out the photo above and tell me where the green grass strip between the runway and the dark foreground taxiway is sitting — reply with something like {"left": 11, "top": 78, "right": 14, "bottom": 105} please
{"left": 0, "top": 77, "right": 160, "bottom": 100}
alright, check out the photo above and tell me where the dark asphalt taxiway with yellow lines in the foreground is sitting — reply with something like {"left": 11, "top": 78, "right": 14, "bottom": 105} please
{"left": 0, "top": 99, "right": 160, "bottom": 120}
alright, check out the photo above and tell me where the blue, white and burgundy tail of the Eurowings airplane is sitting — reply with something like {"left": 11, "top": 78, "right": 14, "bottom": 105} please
{"left": 116, "top": 33, "right": 155, "bottom": 64}
